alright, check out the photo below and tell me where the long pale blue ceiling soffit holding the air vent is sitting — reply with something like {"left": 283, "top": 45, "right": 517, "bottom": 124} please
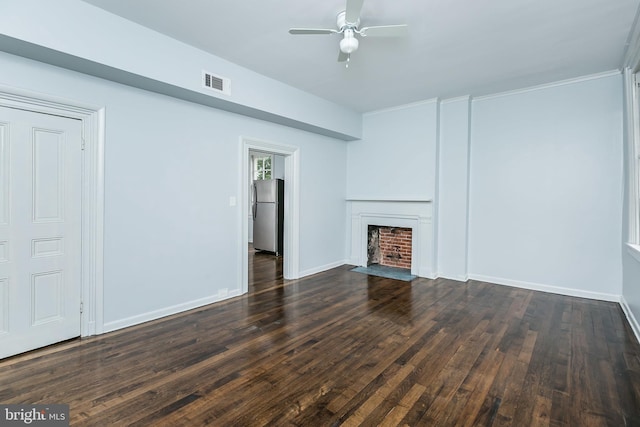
{"left": 0, "top": 0, "right": 362, "bottom": 140}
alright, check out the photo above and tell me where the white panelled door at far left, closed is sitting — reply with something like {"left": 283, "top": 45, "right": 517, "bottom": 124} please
{"left": 0, "top": 107, "right": 82, "bottom": 358}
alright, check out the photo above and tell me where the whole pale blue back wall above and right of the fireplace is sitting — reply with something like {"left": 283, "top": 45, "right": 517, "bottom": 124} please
{"left": 347, "top": 73, "right": 624, "bottom": 304}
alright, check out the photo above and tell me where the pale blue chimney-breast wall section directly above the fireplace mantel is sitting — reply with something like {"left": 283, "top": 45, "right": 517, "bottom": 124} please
{"left": 347, "top": 100, "right": 438, "bottom": 200}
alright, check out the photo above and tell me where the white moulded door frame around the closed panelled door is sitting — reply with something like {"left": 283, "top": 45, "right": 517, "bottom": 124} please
{"left": 0, "top": 85, "right": 105, "bottom": 336}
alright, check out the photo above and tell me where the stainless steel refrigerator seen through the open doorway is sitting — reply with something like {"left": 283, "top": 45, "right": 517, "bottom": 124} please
{"left": 252, "top": 179, "right": 284, "bottom": 255}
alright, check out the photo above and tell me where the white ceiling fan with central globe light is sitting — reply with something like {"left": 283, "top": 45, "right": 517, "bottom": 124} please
{"left": 289, "top": 0, "right": 408, "bottom": 67}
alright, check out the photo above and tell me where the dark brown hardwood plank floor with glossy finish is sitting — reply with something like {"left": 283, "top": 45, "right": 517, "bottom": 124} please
{"left": 0, "top": 247, "right": 640, "bottom": 426}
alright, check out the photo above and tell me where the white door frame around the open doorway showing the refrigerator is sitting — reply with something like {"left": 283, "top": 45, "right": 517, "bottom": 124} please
{"left": 238, "top": 136, "right": 300, "bottom": 294}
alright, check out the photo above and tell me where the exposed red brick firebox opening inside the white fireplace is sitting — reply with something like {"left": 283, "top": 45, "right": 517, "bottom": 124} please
{"left": 367, "top": 225, "right": 412, "bottom": 269}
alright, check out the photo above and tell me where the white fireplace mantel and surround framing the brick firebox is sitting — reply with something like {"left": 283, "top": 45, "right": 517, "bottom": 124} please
{"left": 347, "top": 198, "right": 433, "bottom": 278}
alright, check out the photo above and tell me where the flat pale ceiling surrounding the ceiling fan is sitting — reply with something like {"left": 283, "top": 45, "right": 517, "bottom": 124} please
{"left": 84, "top": 0, "right": 640, "bottom": 112}
